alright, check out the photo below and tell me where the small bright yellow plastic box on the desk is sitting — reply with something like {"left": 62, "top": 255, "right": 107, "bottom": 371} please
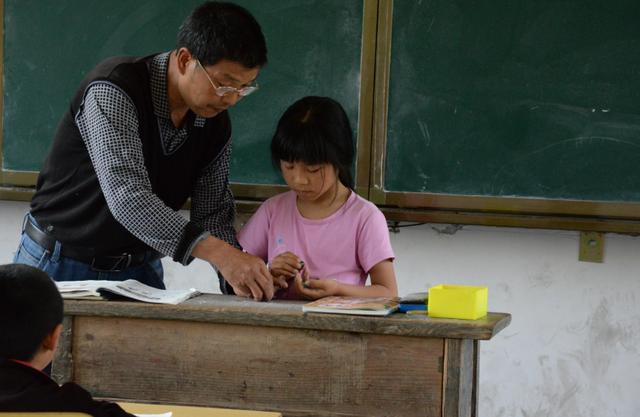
{"left": 427, "top": 284, "right": 489, "bottom": 320}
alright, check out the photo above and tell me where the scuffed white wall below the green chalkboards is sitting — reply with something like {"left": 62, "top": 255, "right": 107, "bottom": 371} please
{"left": 0, "top": 201, "right": 640, "bottom": 417}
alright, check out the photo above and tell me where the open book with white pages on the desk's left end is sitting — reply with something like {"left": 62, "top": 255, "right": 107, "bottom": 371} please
{"left": 56, "top": 279, "right": 200, "bottom": 304}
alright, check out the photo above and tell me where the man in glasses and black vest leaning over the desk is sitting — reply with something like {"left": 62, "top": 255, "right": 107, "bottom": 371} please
{"left": 14, "top": 2, "right": 273, "bottom": 300}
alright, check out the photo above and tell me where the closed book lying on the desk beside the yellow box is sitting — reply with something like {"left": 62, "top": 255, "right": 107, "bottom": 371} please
{"left": 302, "top": 296, "right": 398, "bottom": 316}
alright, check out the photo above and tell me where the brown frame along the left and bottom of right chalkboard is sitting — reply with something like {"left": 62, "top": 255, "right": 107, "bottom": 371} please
{"left": 369, "top": 0, "right": 640, "bottom": 233}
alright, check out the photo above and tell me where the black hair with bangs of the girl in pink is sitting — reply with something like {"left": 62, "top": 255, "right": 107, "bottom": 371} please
{"left": 271, "top": 96, "right": 354, "bottom": 189}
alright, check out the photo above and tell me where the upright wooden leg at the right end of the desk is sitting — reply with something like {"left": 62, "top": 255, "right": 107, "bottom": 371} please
{"left": 442, "top": 339, "right": 477, "bottom": 417}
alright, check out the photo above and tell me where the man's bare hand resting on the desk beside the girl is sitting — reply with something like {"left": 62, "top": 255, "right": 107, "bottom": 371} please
{"left": 192, "top": 236, "right": 274, "bottom": 301}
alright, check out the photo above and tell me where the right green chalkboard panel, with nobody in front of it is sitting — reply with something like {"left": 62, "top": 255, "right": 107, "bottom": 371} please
{"left": 384, "top": 0, "right": 640, "bottom": 202}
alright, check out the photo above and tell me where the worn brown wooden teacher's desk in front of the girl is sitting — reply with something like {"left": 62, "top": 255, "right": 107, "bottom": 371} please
{"left": 53, "top": 295, "right": 511, "bottom": 417}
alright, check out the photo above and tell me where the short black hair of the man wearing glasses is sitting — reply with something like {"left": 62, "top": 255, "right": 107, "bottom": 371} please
{"left": 177, "top": 1, "right": 267, "bottom": 68}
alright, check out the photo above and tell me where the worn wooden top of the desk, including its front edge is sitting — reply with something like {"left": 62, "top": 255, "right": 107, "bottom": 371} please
{"left": 65, "top": 294, "right": 511, "bottom": 340}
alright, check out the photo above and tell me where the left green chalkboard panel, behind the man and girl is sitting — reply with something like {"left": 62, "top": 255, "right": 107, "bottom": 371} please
{"left": 0, "top": 0, "right": 363, "bottom": 184}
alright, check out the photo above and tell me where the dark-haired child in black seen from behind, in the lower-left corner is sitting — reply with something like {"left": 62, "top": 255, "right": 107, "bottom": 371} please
{"left": 0, "top": 265, "right": 132, "bottom": 417}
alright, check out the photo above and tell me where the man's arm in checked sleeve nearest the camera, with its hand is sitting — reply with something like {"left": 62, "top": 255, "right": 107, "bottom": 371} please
{"left": 76, "top": 83, "right": 273, "bottom": 299}
